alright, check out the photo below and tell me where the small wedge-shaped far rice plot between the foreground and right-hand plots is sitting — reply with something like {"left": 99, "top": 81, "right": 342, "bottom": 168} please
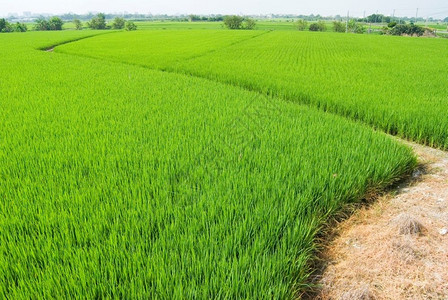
{"left": 56, "top": 30, "right": 265, "bottom": 69}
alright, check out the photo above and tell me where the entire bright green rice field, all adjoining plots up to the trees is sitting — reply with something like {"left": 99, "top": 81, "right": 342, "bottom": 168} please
{"left": 0, "top": 25, "right": 448, "bottom": 299}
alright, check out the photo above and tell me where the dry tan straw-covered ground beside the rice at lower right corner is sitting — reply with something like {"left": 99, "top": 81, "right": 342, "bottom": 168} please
{"left": 318, "top": 143, "right": 448, "bottom": 300}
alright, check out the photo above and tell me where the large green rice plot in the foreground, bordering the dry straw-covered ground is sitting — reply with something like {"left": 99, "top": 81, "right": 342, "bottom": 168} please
{"left": 0, "top": 31, "right": 415, "bottom": 299}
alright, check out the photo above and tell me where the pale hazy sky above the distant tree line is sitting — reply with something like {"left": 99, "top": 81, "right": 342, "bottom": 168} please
{"left": 0, "top": 0, "right": 448, "bottom": 18}
